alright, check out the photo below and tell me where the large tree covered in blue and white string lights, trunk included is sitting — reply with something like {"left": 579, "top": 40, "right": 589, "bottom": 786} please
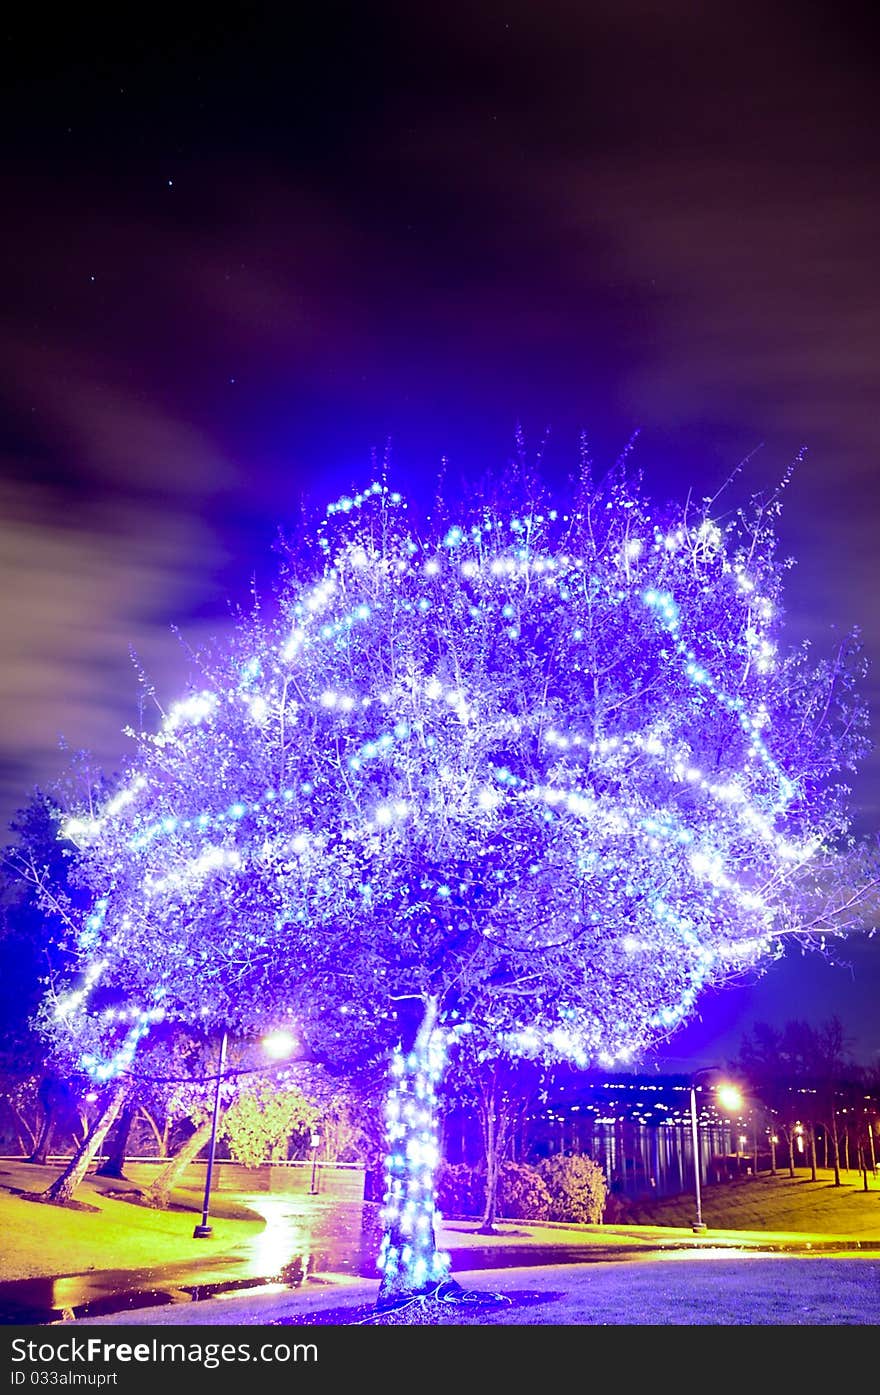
{"left": 56, "top": 463, "right": 865, "bottom": 1303}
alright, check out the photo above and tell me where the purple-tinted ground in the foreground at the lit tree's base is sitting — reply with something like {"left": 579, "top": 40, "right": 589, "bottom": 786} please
{"left": 67, "top": 1250, "right": 880, "bottom": 1328}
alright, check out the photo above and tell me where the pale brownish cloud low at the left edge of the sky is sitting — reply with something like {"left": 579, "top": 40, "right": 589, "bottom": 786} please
{"left": 0, "top": 485, "right": 227, "bottom": 815}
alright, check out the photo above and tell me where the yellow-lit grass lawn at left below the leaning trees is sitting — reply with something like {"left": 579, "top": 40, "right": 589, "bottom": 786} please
{"left": 0, "top": 1159, "right": 265, "bottom": 1281}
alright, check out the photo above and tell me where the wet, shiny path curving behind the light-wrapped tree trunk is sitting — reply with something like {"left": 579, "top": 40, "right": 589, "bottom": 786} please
{"left": 0, "top": 1193, "right": 880, "bottom": 1325}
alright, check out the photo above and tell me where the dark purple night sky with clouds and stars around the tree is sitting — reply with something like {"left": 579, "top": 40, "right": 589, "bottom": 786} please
{"left": 0, "top": 0, "right": 880, "bottom": 1069}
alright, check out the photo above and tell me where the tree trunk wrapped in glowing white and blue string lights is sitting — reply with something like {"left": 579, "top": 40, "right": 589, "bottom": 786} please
{"left": 377, "top": 997, "right": 449, "bottom": 1310}
